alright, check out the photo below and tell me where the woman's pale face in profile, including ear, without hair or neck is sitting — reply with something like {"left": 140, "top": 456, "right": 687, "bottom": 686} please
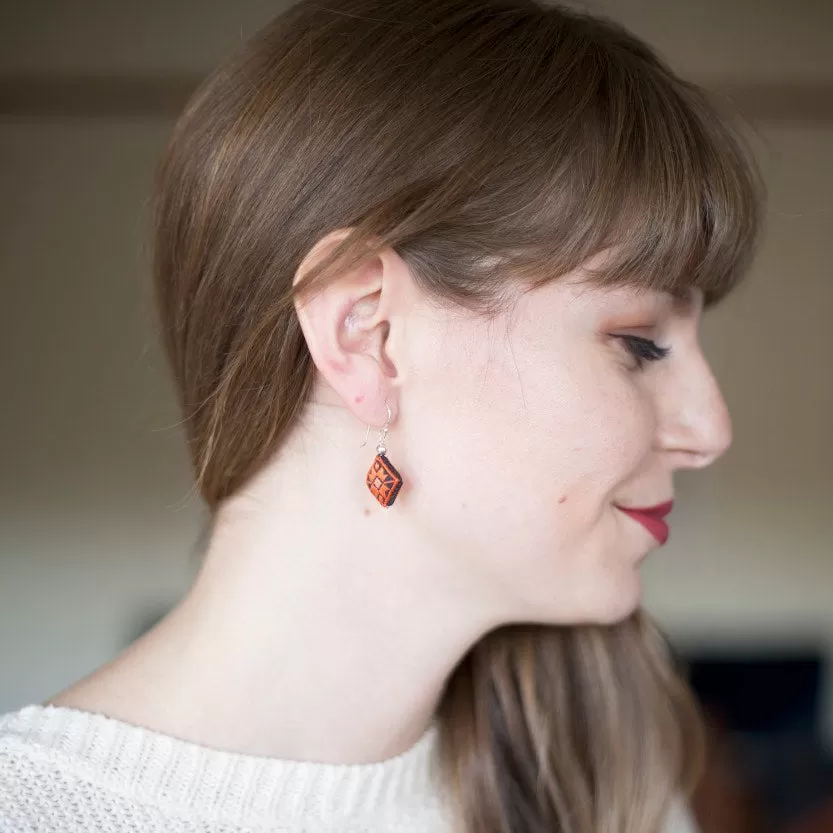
{"left": 290, "top": 235, "right": 731, "bottom": 624}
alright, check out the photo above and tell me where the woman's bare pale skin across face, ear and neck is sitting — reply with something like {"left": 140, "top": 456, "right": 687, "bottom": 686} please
{"left": 51, "top": 231, "right": 731, "bottom": 763}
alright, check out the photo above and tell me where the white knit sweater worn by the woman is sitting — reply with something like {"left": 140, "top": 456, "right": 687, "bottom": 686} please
{"left": 0, "top": 705, "right": 694, "bottom": 833}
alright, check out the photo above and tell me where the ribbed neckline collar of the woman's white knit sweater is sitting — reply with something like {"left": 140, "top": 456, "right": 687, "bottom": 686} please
{"left": 0, "top": 705, "right": 440, "bottom": 829}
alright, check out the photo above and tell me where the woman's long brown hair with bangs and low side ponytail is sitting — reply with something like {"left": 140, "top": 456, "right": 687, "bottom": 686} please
{"left": 154, "top": 0, "right": 761, "bottom": 833}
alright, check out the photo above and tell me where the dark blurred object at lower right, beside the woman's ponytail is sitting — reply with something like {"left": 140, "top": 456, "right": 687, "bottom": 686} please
{"left": 685, "top": 651, "right": 833, "bottom": 833}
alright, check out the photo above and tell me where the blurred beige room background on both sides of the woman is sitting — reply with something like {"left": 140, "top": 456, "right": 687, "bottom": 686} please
{"left": 0, "top": 0, "right": 833, "bottom": 833}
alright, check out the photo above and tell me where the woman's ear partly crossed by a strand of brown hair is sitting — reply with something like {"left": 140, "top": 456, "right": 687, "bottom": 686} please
{"left": 294, "top": 229, "right": 410, "bottom": 427}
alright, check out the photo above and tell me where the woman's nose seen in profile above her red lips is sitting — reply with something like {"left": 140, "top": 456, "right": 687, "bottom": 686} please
{"left": 657, "top": 351, "right": 732, "bottom": 469}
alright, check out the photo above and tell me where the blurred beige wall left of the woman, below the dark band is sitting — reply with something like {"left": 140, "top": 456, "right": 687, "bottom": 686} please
{"left": 0, "top": 118, "right": 205, "bottom": 710}
